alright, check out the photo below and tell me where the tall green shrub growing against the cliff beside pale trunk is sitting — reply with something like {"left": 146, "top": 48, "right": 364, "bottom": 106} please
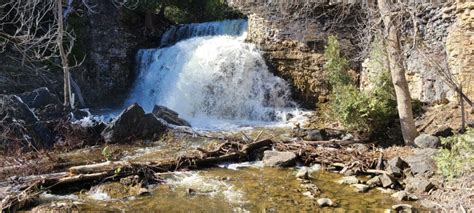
{"left": 324, "top": 36, "right": 397, "bottom": 136}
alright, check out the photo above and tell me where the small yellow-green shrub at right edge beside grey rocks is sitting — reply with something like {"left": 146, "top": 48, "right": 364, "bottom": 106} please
{"left": 434, "top": 129, "right": 474, "bottom": 179}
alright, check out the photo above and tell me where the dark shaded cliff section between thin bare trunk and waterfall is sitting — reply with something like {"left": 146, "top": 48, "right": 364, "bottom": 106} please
{"left": 73, "top": 0, "right": 170, "bottom": 106}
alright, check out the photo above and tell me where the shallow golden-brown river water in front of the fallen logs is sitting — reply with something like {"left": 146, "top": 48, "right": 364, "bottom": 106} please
{"left": 40, "top": 165, "right": 413, "bottom": 212}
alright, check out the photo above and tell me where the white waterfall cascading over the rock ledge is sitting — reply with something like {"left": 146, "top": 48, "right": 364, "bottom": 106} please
{"left": 127, "top": 20, "right": 294, "bottom": 127}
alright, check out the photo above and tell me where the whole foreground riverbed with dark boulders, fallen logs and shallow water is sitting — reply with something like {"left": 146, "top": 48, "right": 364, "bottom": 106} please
{"left": 0, "top": 89, "right": 472, "bottom": 211}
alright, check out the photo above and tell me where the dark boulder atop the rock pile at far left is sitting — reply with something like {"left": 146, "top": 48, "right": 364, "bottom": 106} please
{"left": 18, "top": 87, "right": 61, "bottom": 109}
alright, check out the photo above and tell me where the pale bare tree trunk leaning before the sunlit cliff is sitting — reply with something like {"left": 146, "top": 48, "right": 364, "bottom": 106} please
{"left": 377, "top": 0, "right": 418, "bottom": 145}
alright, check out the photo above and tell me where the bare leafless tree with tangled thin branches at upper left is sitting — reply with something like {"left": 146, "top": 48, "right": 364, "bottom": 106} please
{"left": 0, "top": 0, "right": 87, "bottom": 108}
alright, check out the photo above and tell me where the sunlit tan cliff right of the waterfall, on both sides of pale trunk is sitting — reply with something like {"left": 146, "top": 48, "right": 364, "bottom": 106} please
{"left": 229, "top": 0, "right": 473, "bottom": 107}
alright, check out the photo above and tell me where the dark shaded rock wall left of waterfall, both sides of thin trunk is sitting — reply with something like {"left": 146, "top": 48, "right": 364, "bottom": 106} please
{"left": 0, "top": 0, "right": 170, "bottom": 107}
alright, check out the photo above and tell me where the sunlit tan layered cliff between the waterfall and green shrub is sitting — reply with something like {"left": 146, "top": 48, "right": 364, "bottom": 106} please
{"left": 229, "top": 0, "right": 360, "bottom": 108}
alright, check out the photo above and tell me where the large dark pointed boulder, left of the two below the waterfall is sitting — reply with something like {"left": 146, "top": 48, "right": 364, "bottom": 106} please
{"left": 101, "top": 104, "right": 166, "bottom": 143}
